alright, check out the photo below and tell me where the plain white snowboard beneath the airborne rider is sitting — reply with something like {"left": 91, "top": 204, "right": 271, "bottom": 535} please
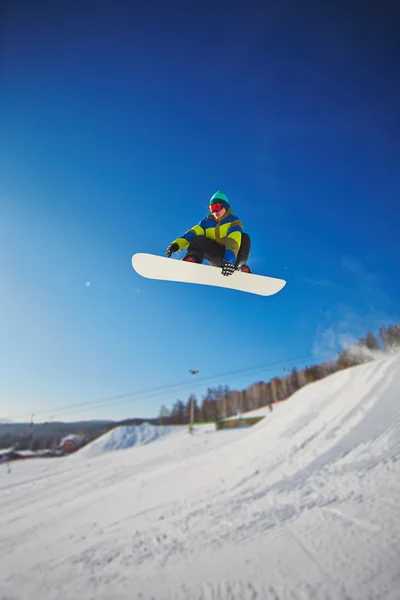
{"left": 132, "top": 252, "right": 286, "bottom": 296}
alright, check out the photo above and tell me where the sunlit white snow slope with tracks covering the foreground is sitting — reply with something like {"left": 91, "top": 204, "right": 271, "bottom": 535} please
{"left": 0, "top": 356, "right": 400, "bottom": 600}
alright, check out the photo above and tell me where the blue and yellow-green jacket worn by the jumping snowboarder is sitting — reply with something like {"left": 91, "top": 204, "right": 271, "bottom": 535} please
{"left": 172, "top": 208, "right": 243, "bottom": 263}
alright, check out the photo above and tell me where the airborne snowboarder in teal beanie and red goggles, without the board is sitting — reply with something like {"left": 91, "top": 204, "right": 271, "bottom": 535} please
{"left": 166, "top": 190, "right": 251, "bottom": 275}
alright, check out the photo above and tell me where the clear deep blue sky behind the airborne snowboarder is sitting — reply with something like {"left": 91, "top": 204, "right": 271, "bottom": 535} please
{"left": 0, "top": 0, "right": 400, "bottom": 420}
